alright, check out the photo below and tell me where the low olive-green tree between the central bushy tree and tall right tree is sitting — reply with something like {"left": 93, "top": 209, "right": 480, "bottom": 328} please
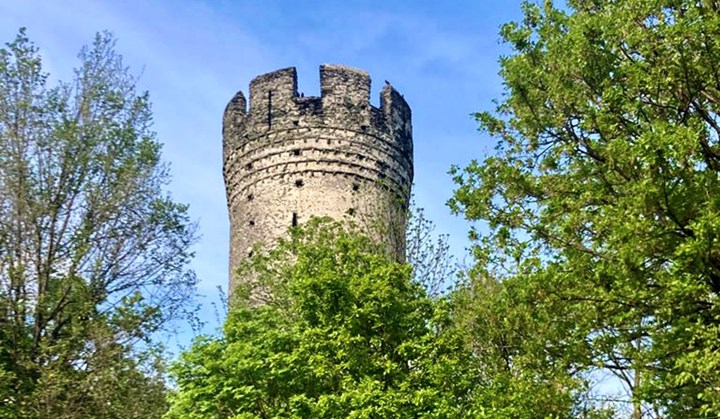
{"left": 449, "top": 278, "right": 613, "bottom": 419}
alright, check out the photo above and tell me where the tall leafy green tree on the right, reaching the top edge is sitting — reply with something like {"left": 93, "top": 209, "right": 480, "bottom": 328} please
{"left": 451, "top": 0, "right": 720, "bottom": 418}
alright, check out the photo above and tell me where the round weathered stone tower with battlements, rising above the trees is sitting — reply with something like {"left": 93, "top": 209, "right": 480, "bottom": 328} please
{"left": 223, "top": 65, "right": 413, "bottom": 289}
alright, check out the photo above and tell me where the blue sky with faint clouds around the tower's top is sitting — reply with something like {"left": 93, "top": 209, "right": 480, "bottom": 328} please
{"left": 0, "top": 0, "right": 520, "bottom": 340}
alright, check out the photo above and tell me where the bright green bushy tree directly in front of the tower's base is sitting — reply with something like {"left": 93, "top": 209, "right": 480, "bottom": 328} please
{"left": 168, "top": 219, "right": 470, "bottom": 418}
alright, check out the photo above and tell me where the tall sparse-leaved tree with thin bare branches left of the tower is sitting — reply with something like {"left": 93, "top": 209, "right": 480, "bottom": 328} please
{"left": 0, "top": 29, "right": 195, "bottom": 418}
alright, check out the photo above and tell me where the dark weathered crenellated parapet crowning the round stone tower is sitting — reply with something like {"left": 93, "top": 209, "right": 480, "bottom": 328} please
{"left": 224, "top": 64, "right": 412, "bottom": 153}
